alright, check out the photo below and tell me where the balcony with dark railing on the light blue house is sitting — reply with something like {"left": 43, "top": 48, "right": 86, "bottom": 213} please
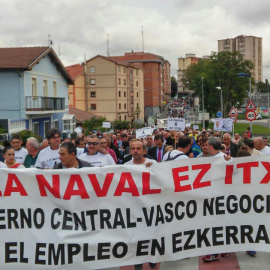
{"left": 25, "top": 97, "right": 65, "bottom": 112}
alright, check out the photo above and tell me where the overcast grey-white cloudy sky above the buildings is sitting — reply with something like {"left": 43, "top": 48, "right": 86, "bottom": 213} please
{"left": 0, "top": 0, "right": 270, "bottom": 79}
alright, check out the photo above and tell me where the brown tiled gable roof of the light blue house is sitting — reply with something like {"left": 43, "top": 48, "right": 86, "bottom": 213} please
{"left": 0, "top": 46, "right": 74, "bottom": 84}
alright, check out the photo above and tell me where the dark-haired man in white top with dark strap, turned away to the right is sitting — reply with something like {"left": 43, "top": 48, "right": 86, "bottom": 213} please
{"left": 162, "top": 135, "right": 191, "bottom": 162}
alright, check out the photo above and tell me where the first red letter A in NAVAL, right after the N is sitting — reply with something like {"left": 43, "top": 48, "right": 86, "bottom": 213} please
{"left": 63, "top": 174, "right": 89, "bottom": 200}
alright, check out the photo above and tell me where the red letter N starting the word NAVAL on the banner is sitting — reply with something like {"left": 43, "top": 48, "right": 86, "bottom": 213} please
{"left": 36, "top": 175, "right": 60, "bottom": 199}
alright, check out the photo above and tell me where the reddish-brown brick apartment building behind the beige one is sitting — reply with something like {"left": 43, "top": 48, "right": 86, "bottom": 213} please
{"left": 110, "top": 51, "right": 171, "bottom": 117}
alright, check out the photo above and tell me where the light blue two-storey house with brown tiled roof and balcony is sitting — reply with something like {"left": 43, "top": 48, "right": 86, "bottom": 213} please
{"left": 0, "top": 47, "right": 74, "bottom": 137}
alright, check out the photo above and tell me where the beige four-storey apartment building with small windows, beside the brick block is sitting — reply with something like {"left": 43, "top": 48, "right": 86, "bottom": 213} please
{"left": 83, "top": 55, "right": 144, "bottom": 121}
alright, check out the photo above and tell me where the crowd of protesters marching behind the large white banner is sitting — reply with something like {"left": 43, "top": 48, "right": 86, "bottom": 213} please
{"left": 0, "top": 127, "right": 270, "bottom": 269}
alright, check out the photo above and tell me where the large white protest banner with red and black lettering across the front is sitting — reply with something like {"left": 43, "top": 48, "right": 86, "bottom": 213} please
{"left": 0, "top": 156, "right": 270, "bottom": 270}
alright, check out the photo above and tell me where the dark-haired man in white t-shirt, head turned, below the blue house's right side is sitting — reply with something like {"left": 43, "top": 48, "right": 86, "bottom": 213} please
{"left": 35, "top": 128, "right": 61, "bottom": 169}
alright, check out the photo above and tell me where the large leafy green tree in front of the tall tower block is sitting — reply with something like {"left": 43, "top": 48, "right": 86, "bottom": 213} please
{"left": 183, "top": 51, "right": 253, "bottom": 117}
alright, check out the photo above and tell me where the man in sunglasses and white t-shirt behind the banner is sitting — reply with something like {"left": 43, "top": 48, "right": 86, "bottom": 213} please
{"left": 78, "top": 135, "right": 115, "bottom": 167}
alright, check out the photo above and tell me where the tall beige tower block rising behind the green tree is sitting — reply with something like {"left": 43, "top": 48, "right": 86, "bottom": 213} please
{"left": 218, "top": 35, "right": 263, "bottom": 82}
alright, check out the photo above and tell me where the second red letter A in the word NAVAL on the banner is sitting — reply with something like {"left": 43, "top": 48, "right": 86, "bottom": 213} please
{"left": 114, "top": 172, "right": 140, "bottom": 196}
